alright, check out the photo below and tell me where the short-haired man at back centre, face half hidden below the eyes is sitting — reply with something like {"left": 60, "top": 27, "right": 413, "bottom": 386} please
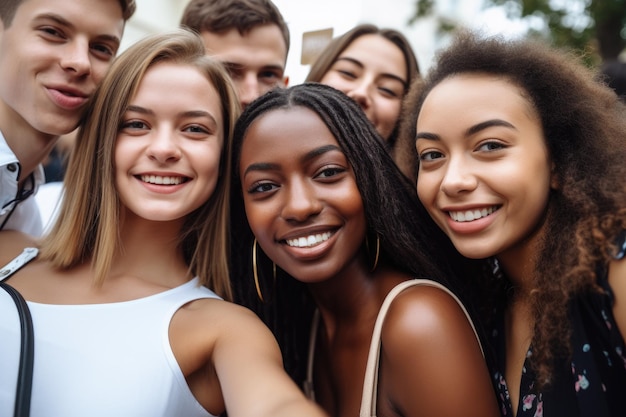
{"left": 181, "top": 0, "right": 289, "bottom": 108}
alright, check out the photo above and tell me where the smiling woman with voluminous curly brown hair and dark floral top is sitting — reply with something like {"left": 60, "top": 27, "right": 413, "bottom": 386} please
{"left": 407, "top": 33, "right": 626, "bottom": 417}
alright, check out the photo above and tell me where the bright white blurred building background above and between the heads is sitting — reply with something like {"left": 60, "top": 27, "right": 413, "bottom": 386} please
{"left": 122, "top": 0, "right": 523, "bottom": 85}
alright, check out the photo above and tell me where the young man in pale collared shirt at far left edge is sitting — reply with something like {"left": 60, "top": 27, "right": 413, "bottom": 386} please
{"left": 0, "top": 0, "right": 135, "bottom": 235}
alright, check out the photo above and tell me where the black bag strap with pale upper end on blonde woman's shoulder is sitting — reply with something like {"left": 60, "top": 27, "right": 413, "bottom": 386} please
{"left": 0, "top": 248, "right": 38, "bottom": 417}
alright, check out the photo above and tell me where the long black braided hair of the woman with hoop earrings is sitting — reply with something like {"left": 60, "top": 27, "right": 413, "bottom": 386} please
{"left": 231, "top": 83, "right": 478, "bottom": 383}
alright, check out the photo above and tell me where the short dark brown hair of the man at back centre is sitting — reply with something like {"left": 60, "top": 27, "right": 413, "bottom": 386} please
{"left": 180, "top": 0, "right": 290, "bottom": 52}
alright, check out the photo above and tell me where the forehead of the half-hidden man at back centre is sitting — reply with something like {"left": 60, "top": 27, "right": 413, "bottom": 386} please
{"left": 201, "top": 24, "right": 287, "bottom": 66}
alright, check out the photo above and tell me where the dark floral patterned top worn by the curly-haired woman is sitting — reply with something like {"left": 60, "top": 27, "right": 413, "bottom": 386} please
{"left": 491, "top": 236, "right": 626, "bottom": 417}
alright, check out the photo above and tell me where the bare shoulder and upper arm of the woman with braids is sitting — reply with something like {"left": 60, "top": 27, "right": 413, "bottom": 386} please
{"left": 379, "top": 286, "right": 500, "bottom": 417}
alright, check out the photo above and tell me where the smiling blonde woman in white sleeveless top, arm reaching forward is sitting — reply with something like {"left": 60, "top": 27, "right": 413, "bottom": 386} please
{"left": 0, "top": 30, "right": 322, "bottom": 417}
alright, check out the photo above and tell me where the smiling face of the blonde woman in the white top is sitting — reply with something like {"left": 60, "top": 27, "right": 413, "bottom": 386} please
{"left": 115, "top": 63, "right": 224, "bottom": 222}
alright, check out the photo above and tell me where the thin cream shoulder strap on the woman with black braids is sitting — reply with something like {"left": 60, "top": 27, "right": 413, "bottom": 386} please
{"left": 359, "top": 279, "right": 485, "bottom": 417}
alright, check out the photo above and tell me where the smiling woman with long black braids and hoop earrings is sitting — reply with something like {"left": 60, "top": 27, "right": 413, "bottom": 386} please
{"left": 231, "top": 83, "right": 498, "bottom": 417}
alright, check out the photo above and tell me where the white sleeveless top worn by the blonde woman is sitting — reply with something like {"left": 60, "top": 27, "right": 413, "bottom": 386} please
{"left": 0, "top": 272, "right": 219, "bottom": 417}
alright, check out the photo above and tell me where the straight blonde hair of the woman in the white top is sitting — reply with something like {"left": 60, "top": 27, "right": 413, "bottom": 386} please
{"left": 41, "top": 29, "right": 240, "bottom": 300}
